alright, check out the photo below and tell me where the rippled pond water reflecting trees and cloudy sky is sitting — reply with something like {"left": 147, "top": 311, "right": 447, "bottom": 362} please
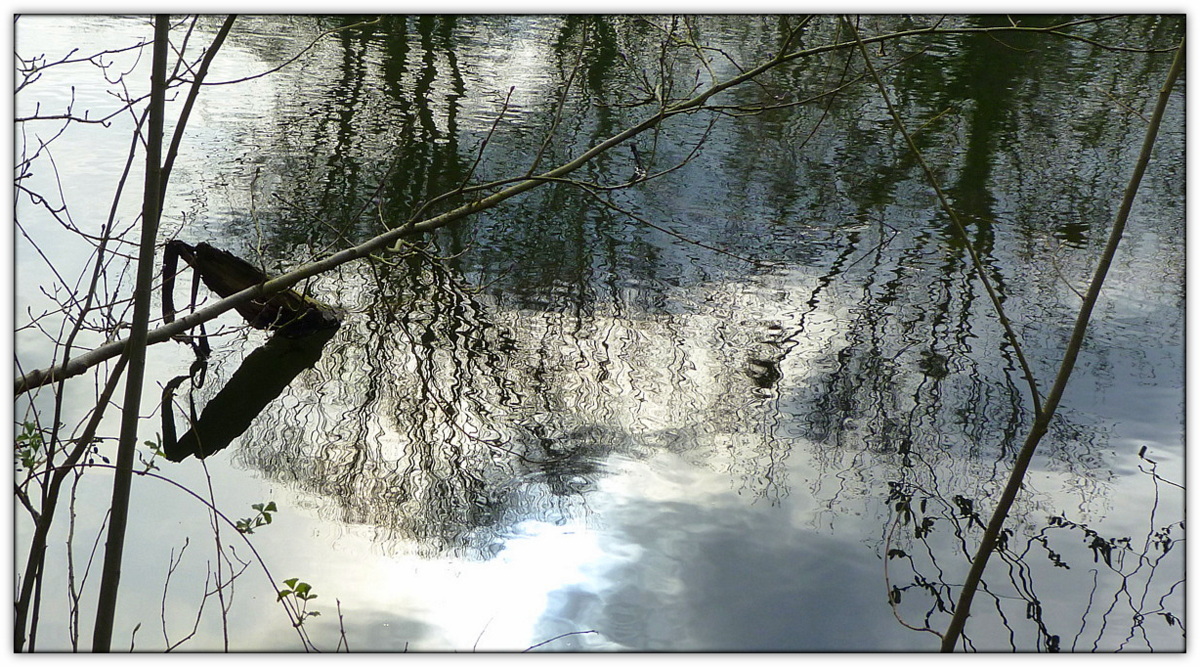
{"left": 16, "top": 16, "right": 1186, "bottom": 651}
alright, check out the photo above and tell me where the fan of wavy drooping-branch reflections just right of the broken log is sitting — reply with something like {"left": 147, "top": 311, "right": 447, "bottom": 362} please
{"left": 228, "top": 254, "right": 540, "bottom": 556}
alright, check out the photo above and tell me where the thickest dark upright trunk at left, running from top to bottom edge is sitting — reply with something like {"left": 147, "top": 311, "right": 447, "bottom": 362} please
{"left": 92, "top": 14, "right": 169, "bottom": 653}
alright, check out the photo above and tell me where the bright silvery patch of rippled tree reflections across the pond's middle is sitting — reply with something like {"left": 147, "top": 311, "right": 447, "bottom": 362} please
{"left": 225, "top": 239, "right": 801, "bottom": 558}
